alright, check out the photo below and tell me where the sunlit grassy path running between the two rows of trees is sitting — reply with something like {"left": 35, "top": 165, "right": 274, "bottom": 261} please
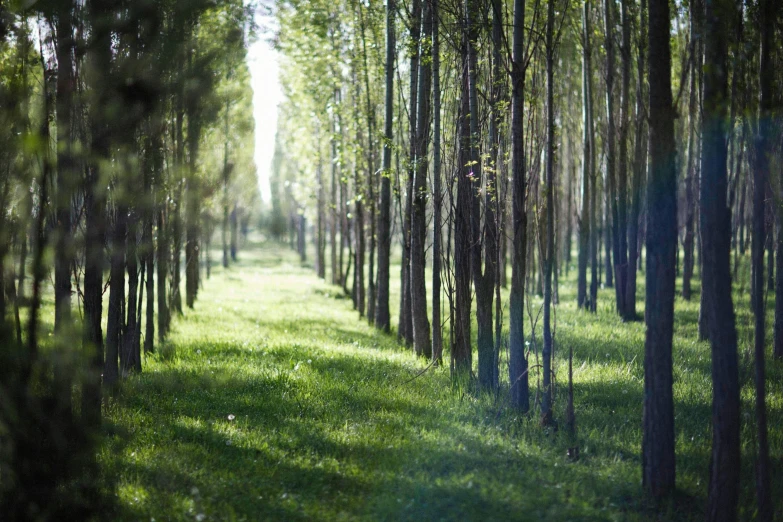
{"left": 101, "top": 241, "right": 724, "bottom": 520}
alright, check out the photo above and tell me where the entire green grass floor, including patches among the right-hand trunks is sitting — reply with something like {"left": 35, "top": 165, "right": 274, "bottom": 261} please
{"left": 100, "top": 237, "right": 783, "bottom": 521}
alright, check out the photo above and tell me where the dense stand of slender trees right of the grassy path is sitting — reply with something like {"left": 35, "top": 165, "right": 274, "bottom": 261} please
{"left": 272, "top": 0, "right": 783, "bottom": 520}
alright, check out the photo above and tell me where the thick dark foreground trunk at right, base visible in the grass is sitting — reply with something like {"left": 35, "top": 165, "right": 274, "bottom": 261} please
{"left": 642, "top": 0, "right": 677, "bottom": 498}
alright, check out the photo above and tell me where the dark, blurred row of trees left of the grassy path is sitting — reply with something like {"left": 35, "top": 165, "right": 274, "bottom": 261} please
{"left": 0, "top": 0, "right": 258, "bottom": 520}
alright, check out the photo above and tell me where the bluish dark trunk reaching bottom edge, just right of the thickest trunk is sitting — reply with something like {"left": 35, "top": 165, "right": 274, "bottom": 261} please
{"left": 704, "top": 0, "right": 740, "bottom": 521}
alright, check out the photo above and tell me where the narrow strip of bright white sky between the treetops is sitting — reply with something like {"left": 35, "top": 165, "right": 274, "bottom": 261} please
{"left": 248, "top": 9, "right": 283, "bottom": 203}
